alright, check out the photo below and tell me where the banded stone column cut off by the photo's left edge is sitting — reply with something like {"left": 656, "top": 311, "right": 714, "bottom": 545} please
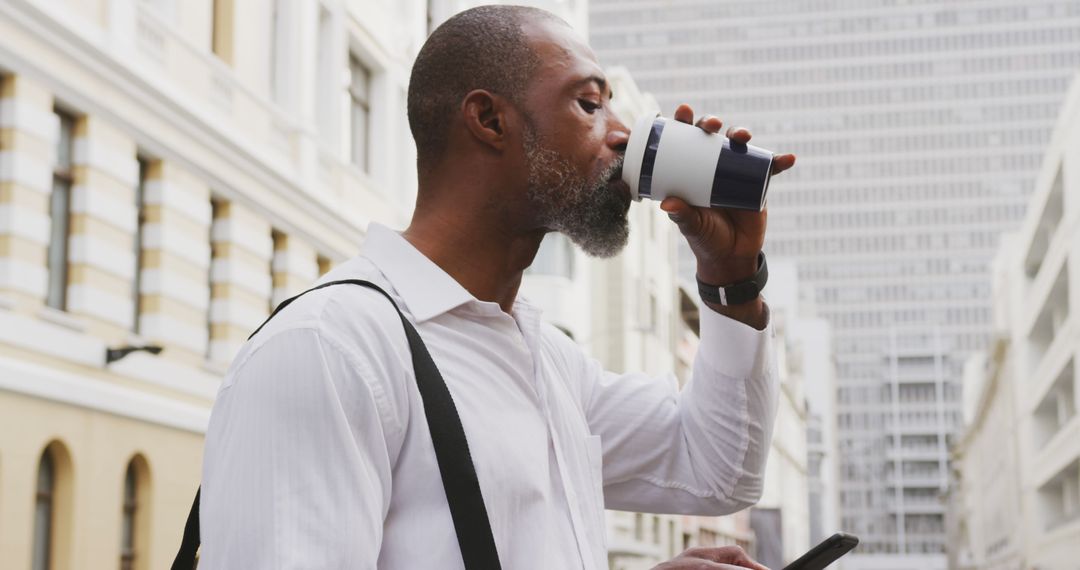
{"left": 0, "top": 76, "right": 59, "bottom": 306}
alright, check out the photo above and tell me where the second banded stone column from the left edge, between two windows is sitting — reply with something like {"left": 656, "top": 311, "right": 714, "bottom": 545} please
{"left": 67, "top": 116, "right": 138, "bottom": 340}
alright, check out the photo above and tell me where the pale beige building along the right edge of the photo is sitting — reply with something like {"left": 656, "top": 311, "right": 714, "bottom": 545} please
{"left": 949, "top": 74, "right": 1080, "bottom": 570}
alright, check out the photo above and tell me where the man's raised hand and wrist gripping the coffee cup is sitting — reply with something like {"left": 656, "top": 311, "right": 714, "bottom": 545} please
{"left": 660, "top": 105, "right": 795, "bottom": 329}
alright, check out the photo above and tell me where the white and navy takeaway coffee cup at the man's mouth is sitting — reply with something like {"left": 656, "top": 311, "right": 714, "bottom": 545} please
{"left": 622, "top": 116, "right": 772, "bottom": 212}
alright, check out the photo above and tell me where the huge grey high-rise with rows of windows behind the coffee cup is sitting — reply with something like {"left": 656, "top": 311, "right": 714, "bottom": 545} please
{"left": 589, "top": 0, "right": 1080, "bottom": 568}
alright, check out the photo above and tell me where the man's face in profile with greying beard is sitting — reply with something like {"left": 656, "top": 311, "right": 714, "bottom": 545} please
{"left": 522, "top": 22, "right": 631, "bottom": 257}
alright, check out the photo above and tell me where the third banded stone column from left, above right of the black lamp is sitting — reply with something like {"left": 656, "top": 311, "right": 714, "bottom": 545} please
{"left": 138, "top": 161, "right": 211, "bottom": 364}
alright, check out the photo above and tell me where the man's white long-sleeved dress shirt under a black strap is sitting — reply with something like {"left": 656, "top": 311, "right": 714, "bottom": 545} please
{"left": 200, "top": 225, "right": 777, "bottom": 570}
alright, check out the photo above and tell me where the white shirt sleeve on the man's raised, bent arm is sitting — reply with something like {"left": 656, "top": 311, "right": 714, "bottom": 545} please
{"left": 582, "top": 310, "right": 779, "bottom": 516}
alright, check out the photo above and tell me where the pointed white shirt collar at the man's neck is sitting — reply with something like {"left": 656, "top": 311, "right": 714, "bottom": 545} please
{"left": 361, "top": 222, "right": 479, "bottom": 323}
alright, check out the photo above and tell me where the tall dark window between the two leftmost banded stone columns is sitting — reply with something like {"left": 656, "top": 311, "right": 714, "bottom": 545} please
{"left": 45, "top": 110, "right": 75, "bottom": 311}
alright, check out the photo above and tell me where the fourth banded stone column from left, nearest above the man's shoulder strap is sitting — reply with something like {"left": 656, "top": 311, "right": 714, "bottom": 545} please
{"left": 208, "top": 201, "right": 273, "bottom": 364}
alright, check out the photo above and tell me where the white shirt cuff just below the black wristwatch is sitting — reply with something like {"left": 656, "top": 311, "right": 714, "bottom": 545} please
{"left": 698, "top": 306, "right": 775, "bottom": 378}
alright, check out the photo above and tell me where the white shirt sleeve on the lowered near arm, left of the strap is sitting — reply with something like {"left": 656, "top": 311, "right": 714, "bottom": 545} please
{"left": 200, "top": 328, "right": 392, "bottom": 569}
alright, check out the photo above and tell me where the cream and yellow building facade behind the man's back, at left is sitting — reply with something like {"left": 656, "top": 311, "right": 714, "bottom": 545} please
{"left": 0, "top": 0, "right": 429, "bottom": 569}
